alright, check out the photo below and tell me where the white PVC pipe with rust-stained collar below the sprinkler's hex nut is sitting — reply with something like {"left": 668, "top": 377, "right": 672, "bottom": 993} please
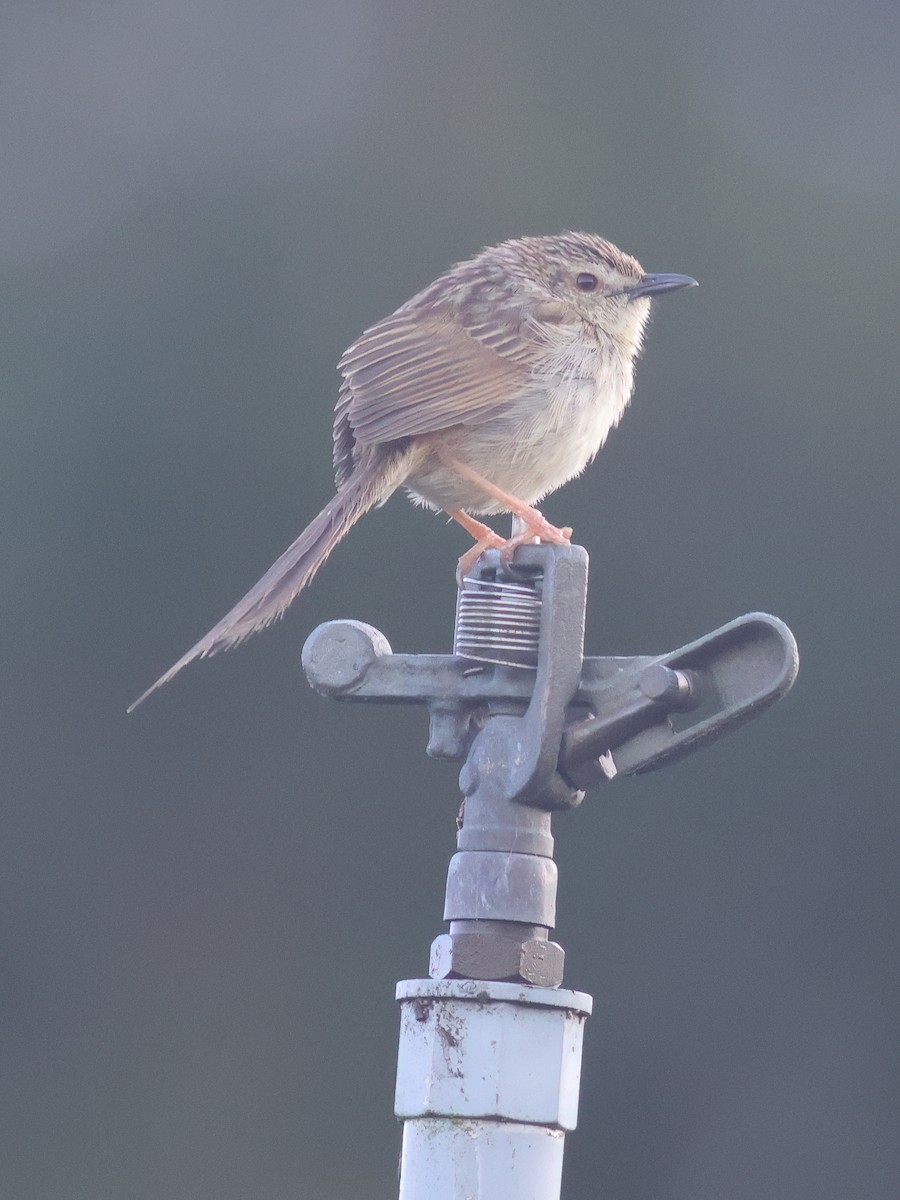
{"left": 395, "top": 979, "right": 592, "bottom": 1200}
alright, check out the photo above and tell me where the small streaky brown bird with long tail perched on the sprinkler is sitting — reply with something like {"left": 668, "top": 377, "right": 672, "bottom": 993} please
{"left": 128, "top": 233, "right": 696, "bottom": 712}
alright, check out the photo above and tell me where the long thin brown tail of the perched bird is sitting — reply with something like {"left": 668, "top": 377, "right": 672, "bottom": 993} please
{"left": 127, "top": 460, "right": 400, "bottom": 713}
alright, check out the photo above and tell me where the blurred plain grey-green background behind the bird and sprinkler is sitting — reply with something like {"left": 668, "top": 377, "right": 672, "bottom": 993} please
{"left": 0, "top": 0, "right": 900, "bottom": 1200}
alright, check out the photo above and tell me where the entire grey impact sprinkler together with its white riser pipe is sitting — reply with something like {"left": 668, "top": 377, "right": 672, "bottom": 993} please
{"left": 302, "top": 545, "right": 797, "bottom": 1200}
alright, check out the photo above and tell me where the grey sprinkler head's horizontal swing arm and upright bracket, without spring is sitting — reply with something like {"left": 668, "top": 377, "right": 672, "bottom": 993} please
{"left": 302, "top": 545, "right": 798, "bottom": 808}
